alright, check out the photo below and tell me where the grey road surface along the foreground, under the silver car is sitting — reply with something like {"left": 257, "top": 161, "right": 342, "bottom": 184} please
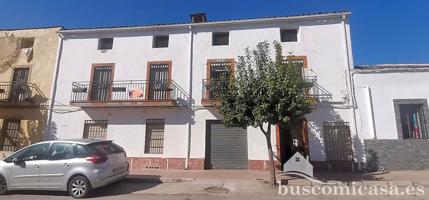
{"left": 0, "top": 182, "right": 429, "bottom": 200}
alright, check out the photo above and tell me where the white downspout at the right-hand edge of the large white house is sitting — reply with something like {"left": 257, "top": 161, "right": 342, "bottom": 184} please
{"left": 341, "top": 15, "right": 363, "bottom": 171}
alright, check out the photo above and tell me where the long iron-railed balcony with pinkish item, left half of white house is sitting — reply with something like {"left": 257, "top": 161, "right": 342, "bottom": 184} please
{"left": 70, "top": 80, "right": 192, "bottom": 107}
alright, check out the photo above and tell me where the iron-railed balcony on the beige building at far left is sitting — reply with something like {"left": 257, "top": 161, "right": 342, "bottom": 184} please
{"left": 0, "top": 82, "right": 47, "bottom": 107}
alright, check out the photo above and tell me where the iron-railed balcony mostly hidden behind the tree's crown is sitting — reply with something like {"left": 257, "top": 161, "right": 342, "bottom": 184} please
{"left": 201, "top": 76, "right": 332, "bottom": 106}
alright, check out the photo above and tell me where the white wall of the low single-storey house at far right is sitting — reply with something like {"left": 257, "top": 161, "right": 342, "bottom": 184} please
{"left": 353, "top": 65, "right": 429, "bottom": 139}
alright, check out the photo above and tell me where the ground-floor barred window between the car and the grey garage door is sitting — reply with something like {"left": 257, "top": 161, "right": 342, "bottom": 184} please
{"left": 144, "top": 119, "right": 165, "bottom": 154}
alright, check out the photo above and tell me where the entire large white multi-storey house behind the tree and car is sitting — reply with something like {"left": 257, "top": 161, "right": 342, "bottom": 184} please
{"left": 50, "top": 12, "right": 363, "bottom": 170}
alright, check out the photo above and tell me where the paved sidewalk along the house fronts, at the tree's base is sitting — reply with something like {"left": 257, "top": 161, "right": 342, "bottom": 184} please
{"left": 127, "top": 169, "right": 429, "bottom": 186}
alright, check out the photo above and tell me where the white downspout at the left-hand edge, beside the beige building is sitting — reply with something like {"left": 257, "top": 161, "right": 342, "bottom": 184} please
{"left": 43, "top": 33, "right": 63, "bottom": 140}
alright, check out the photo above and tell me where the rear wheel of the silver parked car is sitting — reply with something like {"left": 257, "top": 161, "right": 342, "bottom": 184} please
{"left": 67, "top": 176, "right": 92, "bottom": 199}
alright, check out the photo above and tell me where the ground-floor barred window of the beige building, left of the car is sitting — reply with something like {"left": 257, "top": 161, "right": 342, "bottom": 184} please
{"left": 0, "top": 120, "right": 21, "bottom": 151}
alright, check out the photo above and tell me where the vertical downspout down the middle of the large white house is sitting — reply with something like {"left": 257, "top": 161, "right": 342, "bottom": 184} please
{"left": 185, "top": 25, "right": 194, "bottom": 169}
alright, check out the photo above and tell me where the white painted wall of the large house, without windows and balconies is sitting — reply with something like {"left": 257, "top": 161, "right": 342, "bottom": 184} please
{"left": 48, "top": 13, "right": 362, "bottom": 170}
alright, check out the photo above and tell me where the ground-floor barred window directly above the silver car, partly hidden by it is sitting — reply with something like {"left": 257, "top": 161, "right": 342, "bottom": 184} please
{"left": 83, "top": 120, "right": 107, "bottom": 139}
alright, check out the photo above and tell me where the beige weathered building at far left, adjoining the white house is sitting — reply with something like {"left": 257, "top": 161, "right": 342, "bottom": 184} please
{"left": 0, "top": 27, "right": 61, "bottom": 157}
